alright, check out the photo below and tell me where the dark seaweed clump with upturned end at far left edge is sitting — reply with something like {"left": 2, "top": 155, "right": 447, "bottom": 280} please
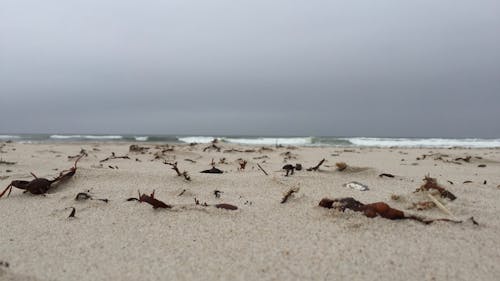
{"left": 0, "top": 155, "right": 84, "bottom": 198}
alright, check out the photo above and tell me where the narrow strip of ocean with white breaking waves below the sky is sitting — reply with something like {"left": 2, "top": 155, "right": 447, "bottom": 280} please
{"left": 0, "top": 134, "right": 500, "bottom": 148}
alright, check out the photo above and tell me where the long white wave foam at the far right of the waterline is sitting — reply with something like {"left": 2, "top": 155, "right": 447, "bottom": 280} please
{"left": 344, "top": 138, "right": 500, "bottom": 148}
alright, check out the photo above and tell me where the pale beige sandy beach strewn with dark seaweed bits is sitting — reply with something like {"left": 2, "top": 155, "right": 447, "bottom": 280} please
{"left": 0, "top": 143, "right": 500, "bottom": 280}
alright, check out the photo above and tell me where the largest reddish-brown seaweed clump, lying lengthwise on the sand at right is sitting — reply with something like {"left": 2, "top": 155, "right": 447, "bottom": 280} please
{"left": 319, "top": 197, "right": 462, "bottom": 224}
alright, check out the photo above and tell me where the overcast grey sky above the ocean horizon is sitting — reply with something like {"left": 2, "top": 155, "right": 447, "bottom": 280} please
{"left": 0, "top": 0, "right": 500, "bottom": 138}
